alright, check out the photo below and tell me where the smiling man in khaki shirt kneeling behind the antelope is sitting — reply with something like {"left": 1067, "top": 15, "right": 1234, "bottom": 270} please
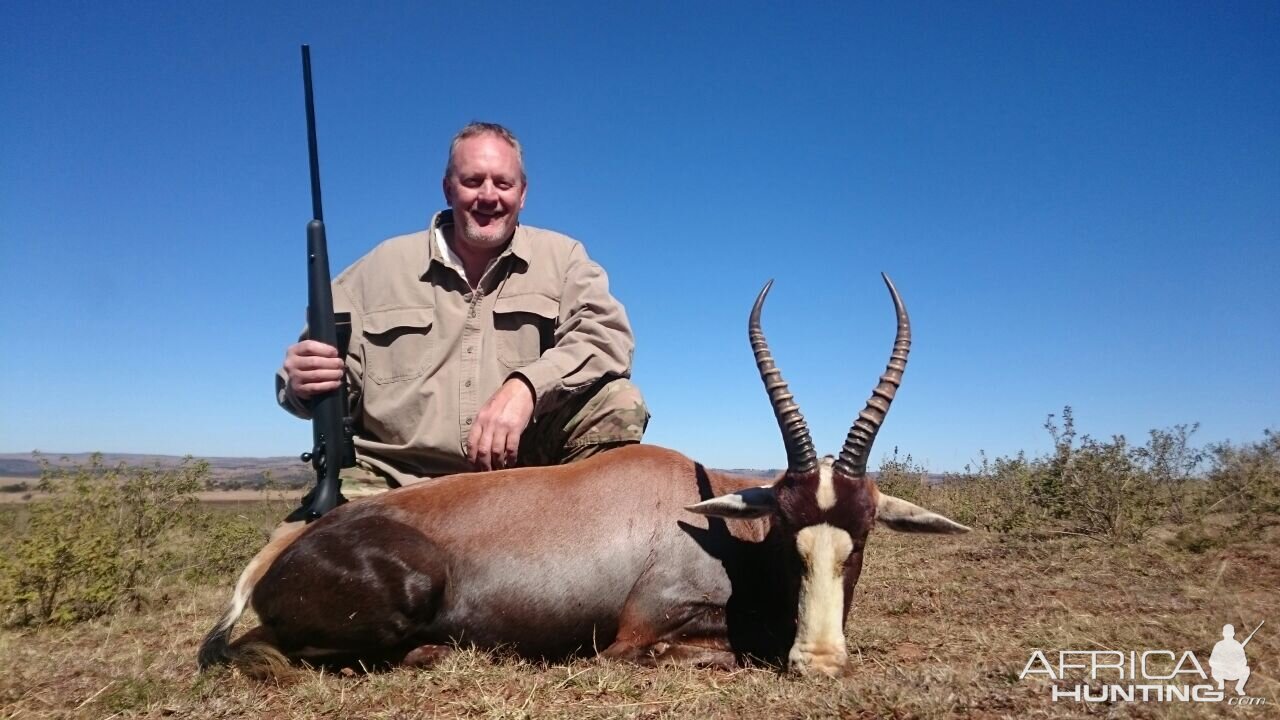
{"left": 276, "top": 123, "right": 649, "bottom": 487}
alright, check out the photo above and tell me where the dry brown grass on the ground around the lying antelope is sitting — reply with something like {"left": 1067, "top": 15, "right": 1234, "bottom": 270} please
{"left": 0, "top": 520, "right": 1280, "bottom": 719}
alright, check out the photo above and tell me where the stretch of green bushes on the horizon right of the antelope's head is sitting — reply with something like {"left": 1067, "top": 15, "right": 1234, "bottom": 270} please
{"left": 877, "top": 406, "right": 1280, "bottom": 540}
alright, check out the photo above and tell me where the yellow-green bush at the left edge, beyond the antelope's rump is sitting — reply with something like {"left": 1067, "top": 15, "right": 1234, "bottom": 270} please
{"left": 0, "top": 455, "right": 209, "bottom": 624}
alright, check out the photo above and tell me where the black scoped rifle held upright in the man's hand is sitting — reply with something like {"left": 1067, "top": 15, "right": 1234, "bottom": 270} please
{"left": 287, "top": 45, "right": 356, "bottom": 515}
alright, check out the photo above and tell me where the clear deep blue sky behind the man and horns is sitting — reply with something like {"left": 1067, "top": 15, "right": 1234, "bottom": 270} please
{"left": 0, "top": 1, "right": 1280, "bottom": 470}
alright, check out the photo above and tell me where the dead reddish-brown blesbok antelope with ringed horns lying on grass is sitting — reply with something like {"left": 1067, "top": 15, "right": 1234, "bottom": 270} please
{"left": 198, "top": 275, "right": 968, "bottom": 675}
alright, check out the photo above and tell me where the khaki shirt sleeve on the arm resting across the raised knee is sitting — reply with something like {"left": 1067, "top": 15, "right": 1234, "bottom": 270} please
{"left": 513, "top": 243, "right": 635, "bottom": 415}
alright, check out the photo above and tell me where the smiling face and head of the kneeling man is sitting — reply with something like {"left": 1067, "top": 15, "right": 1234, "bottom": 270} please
{"left": 444, "top": 135, "right": 527, "bottom": 250}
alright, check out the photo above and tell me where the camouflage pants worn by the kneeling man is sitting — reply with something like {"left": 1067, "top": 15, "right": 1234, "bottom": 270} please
{"left": 342, "top": 378, "right": 649, "bottom": 498}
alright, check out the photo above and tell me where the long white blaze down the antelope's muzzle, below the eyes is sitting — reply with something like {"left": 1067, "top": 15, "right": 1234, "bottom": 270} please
{"left": 787, "top": 523, "right": 854, "bottom": 676}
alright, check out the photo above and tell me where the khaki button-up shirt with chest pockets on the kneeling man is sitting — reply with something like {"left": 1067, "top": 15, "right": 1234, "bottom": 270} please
{"left": 276, "top": 210, "right": 635, "bottom": 484}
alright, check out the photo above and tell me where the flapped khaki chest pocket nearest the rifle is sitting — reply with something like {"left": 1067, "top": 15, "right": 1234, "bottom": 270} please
{"left": 364, "top": 307, "right": 435, "bottom": 384}
